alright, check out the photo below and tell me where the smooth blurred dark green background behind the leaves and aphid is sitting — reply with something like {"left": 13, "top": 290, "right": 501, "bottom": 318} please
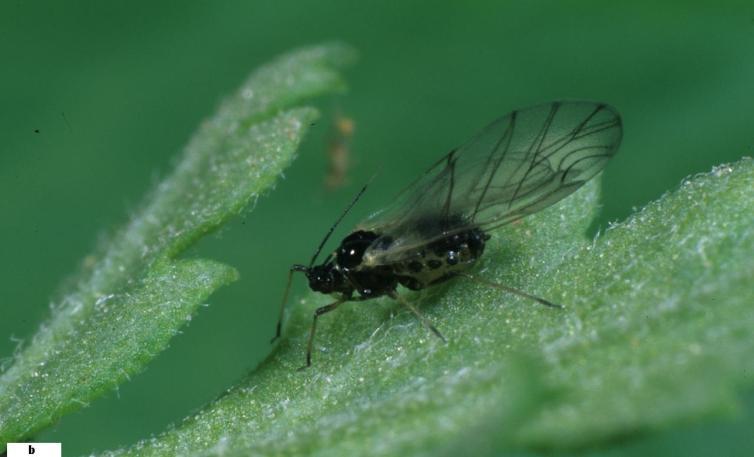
{"left": 0, "top": 0, "right": 754, "bottom": 455}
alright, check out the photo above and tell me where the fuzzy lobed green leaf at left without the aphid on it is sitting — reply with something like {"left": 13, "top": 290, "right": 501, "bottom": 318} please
{"left": 0, "top": 45, "right": 352, "bottom": 442}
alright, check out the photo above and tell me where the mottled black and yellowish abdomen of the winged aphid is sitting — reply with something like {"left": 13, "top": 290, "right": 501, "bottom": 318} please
{"left": 392, "top": 228, "right": 489, "bottom": 290}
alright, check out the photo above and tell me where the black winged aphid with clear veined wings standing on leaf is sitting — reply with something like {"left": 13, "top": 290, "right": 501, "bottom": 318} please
{"left": 273, "top": 101, "right": 622, "bottom": 366}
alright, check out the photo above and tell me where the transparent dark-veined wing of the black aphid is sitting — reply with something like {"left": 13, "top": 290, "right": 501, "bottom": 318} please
{"left": 360, "top": 101, "right": 622, "bottom": 264}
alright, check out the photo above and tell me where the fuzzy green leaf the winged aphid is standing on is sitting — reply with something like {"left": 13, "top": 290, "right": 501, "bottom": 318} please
{"left": 92, "top": 155, "right": 754, "bottom": 456}
